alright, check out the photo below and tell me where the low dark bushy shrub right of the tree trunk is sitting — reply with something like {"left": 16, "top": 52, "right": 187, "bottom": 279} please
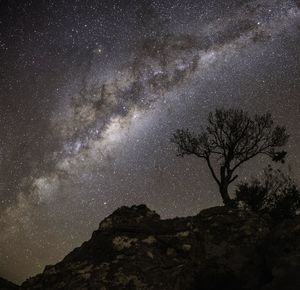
{"left": 236, "top": 165, "right": 300, "bottom": 221}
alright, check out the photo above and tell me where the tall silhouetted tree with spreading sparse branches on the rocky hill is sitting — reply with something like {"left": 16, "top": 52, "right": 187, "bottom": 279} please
{"left": 171, "top": 109, "right": 288, "bottom": 206}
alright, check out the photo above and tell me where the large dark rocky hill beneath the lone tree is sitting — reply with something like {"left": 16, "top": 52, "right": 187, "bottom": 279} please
{"left": 21, "top": 205, "right": 300, "bottom": 290}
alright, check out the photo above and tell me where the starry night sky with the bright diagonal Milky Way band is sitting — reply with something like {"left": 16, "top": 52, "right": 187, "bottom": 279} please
{"left": 0, "top": 0, "right": 300, "bottom": 283}
